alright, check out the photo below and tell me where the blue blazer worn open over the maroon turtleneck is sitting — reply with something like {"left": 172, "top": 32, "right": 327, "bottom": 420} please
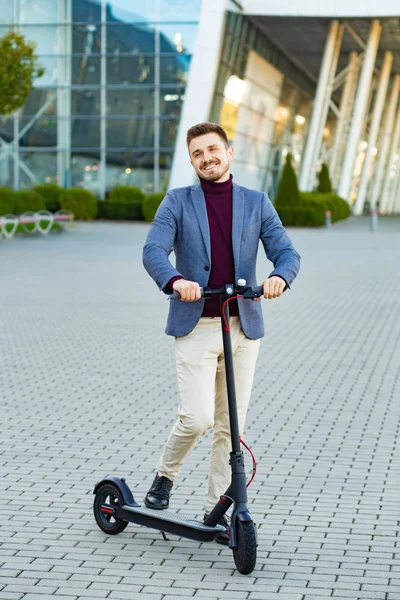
{"left": 143, "top": 183, "right": 300, "bottom": 339}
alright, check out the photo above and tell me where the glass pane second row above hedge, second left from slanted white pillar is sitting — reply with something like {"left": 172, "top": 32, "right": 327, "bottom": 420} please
{"left": 107, "top": 117, "right": 154, "bottom": 148}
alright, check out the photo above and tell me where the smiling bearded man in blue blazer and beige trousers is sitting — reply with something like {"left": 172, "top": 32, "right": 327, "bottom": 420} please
{"left": 143, "top": 123, "right": 300, "bottom": 544}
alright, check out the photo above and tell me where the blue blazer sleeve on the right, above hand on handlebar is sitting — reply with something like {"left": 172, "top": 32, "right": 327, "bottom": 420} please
{"left": 260, "top": 193, "right": 300, "bottom": 287}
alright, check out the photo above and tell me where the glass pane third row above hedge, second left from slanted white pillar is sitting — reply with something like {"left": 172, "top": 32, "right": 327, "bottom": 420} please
{"left": 106, "top": 88, "right": 154, "bottom": 116}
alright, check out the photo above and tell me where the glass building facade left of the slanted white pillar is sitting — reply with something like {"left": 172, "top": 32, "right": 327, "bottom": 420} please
{"left": 0, "top": 0, "right": 201, "bottom": 197}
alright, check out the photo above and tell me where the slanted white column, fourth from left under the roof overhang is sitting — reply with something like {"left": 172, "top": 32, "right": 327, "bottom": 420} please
{"left": 354, "top": 52, "right": 393, "bottom": 215}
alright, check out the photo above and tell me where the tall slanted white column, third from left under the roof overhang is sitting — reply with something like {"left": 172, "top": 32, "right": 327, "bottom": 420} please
{"left": 338, "top": 19, "right": 382, "bottom": 200}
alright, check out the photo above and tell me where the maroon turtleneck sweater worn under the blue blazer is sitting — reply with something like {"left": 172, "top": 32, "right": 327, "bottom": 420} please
{"left": 168, "top": 175, "right": 239, "bottom": 317}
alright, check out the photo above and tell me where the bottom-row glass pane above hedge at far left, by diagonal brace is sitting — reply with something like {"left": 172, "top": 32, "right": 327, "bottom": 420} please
{"left": 19, "top": 152, "right": 58, "bottom": 188}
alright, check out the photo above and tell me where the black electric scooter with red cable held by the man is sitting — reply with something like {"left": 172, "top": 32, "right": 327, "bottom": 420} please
{"left": 93, "top": 279, "right": 263, "bottom": 575}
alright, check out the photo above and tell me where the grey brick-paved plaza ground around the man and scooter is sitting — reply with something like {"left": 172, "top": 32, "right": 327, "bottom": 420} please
{"left": 0, "top": 219, "right": 400, "bottom": 600}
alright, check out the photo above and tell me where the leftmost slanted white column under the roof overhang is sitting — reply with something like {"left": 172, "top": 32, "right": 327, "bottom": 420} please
{"left": 299, "top": 20, "right": 339, "bottom": 191}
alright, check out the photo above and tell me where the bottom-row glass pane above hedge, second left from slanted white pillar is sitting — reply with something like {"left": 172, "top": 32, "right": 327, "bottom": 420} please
{"left": 106, "top": 151, "right": 154, "bottom": 194}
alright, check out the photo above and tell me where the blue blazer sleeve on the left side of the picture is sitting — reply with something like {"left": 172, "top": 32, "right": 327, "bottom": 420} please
{"left": 143, "top": 192, "right": 182, "bottom": 293}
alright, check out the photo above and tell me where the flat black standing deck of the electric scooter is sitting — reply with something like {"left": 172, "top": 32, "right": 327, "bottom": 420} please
{"left": 113, "top": 504, "right": 225, "bottom": 542}
